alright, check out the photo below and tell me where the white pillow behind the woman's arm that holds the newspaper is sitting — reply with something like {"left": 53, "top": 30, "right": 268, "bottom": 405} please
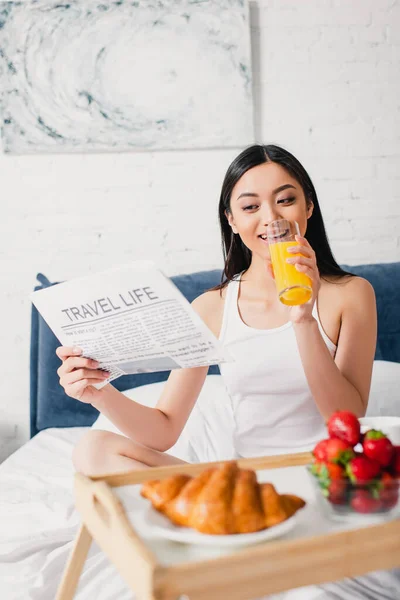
{"left": 92, "top": 375, "right": 234, "bottom": 462}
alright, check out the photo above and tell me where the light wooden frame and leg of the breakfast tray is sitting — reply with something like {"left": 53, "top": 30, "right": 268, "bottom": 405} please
{"left": 57, "top": 453, "right": 400, "bottom": 600}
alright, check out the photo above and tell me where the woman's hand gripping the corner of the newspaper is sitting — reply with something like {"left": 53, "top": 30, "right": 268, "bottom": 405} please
{"left": 56, "top": 346, "right": 110, "bottom": 404}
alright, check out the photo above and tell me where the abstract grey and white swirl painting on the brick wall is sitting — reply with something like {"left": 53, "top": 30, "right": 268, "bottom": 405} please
{"left": 0, "top": 0, "right": 254, "bottom": 154}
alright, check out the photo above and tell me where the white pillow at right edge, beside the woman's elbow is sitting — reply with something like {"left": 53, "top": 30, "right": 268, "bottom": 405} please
{"left": 367, "top": 360, "right": 400, "bottom": 417}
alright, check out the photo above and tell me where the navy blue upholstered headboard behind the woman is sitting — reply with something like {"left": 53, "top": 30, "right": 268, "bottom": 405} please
{"left": 30, "top": 262, "right": 400, "bottom": 436}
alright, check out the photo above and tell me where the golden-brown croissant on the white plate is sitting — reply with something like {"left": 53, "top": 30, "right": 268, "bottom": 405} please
{"left": 141, "top": 461, "right": 305, "bottom": 535}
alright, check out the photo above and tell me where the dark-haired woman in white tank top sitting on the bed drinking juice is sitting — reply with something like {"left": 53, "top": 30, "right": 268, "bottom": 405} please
{"left": 57, "top": 145, "right": 376, "bottom": 475}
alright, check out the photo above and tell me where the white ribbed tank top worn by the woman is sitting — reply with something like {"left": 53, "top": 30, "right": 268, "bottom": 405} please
{"left": 219, "top": 275, "right": 336, "bottom": 457}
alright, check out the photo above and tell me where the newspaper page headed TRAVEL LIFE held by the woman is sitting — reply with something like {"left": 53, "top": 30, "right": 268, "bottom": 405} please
{"left": 31, "top": 261, "right": 229, "bottom": 387}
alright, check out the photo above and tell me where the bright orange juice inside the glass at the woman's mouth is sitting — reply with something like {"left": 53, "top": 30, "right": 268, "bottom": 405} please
{"left": 269, "top": 241, "right": 312, "bottom": 306}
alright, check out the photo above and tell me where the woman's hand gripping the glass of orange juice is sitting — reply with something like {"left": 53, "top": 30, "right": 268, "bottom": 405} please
{"left": 287, "top": 235, "right": 321, "bottom": 323}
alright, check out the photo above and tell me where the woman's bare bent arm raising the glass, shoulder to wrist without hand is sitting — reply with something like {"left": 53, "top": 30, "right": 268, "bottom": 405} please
{"left": 293, "top": 277, "right": 377, "bottom": 419}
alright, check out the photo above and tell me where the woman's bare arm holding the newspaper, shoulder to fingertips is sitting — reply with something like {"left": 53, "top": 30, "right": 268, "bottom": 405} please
{"left": 56, "top": 291, "right": 223, "bottom": 451}
